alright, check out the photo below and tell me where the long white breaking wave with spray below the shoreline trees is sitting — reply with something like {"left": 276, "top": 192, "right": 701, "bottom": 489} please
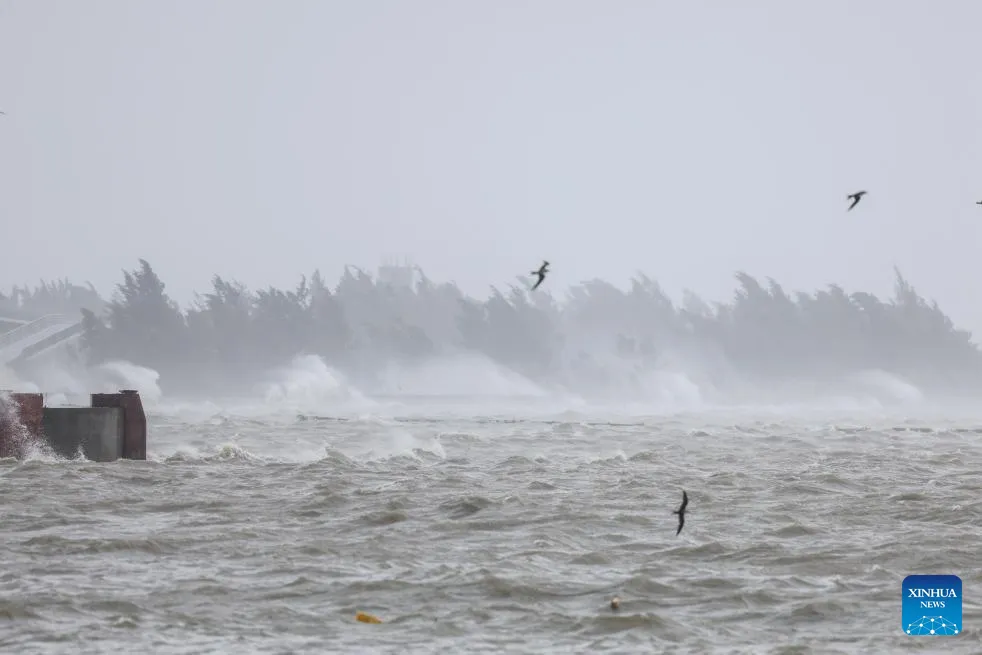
{"left": 0, "top": 346, "right": 943, "bottom": 420}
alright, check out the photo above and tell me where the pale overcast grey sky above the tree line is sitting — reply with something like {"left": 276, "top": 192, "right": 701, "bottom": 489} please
{"left": 0, "top": 0, "right": 982, "bottom": 329}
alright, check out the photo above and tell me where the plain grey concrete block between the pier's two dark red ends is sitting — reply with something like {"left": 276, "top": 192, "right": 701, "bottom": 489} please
{"left": 42, "top": 407, "right": 124, "bottom": 462}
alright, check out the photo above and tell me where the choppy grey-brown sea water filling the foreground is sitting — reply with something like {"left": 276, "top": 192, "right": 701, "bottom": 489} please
{"left": 0, "top": 392, "right": 982, "bottom": 653}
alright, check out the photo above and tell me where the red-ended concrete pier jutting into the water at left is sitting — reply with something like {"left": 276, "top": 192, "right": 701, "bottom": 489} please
{"left": 0, "top": 390, "right": 147, "bottom": 462}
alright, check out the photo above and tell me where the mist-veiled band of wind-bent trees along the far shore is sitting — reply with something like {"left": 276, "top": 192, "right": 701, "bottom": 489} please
{"left": 7, "top": 260, "right": 982, "bottom": 401}
